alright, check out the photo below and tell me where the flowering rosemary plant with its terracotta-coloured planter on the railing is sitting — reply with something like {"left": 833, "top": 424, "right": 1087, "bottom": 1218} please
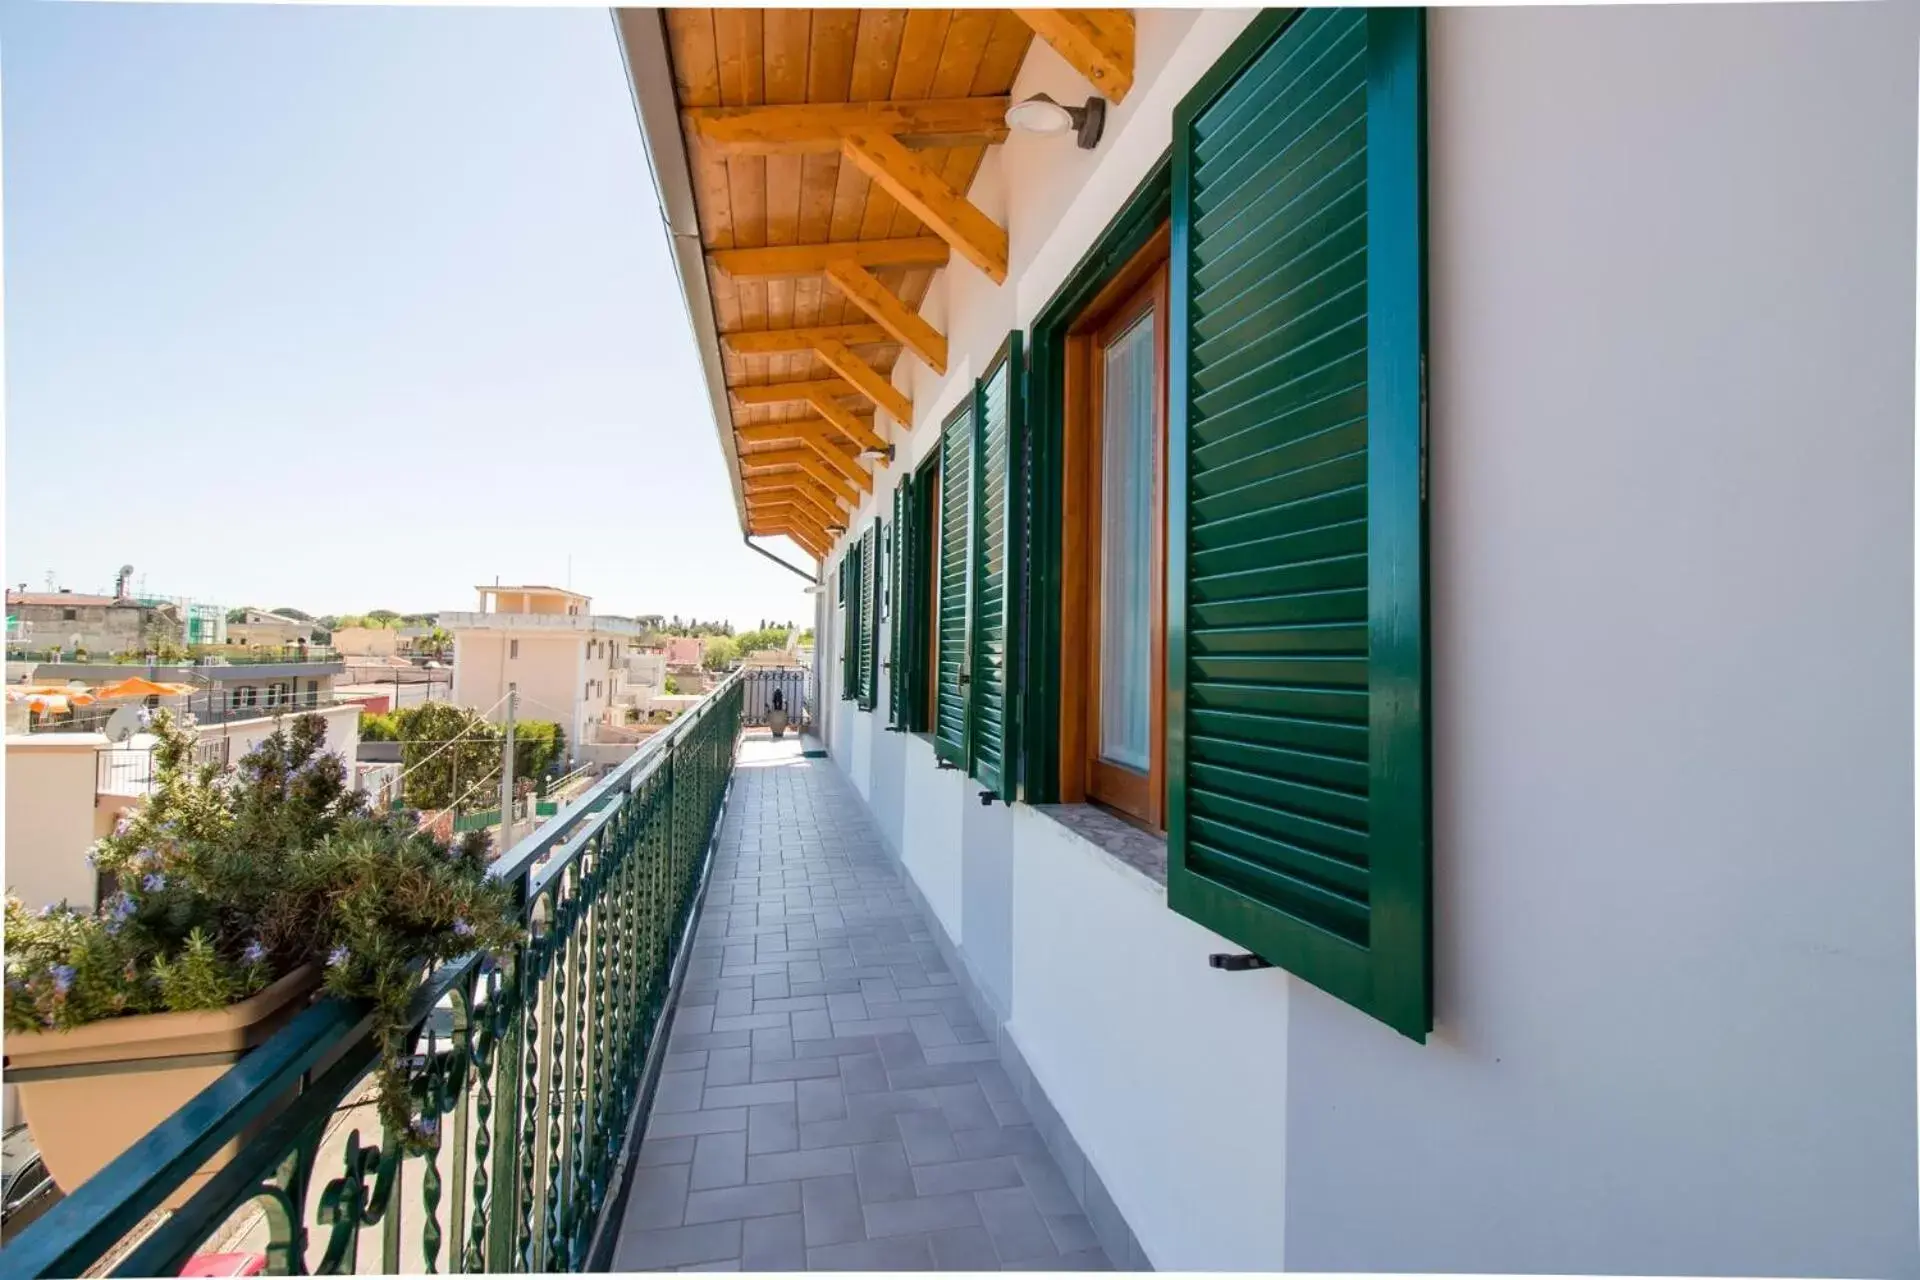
{"left": 4, "top": 710, "right": 522, "bottom": 1205}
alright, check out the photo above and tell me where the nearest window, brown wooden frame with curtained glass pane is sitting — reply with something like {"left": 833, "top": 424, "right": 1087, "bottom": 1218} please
{"left": 1060, "top": 226, "right": 1169, "bottom": 829}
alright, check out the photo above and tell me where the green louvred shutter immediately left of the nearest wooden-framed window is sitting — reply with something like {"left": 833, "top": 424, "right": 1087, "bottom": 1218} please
{"left": 968, "top": 332, "right": 1020, "bottom": 800}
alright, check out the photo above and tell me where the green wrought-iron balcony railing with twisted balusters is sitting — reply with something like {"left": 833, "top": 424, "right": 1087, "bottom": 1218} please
{"left": 0, "top": 677, "right": 743, "bottom": 1280}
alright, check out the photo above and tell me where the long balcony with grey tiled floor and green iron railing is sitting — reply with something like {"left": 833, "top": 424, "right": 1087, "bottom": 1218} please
{"left": 6, "top": 674, "right": 1108, "bottom": 1276}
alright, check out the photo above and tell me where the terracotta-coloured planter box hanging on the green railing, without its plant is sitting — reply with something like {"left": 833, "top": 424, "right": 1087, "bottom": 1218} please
{"left": 6, "top": 965, "right": 319, "bottom": 1209}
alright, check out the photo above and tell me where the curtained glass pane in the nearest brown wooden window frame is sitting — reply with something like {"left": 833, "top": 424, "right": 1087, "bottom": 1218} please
{"left": 1100, "top": 313, "right": 1154, "bottom": 773}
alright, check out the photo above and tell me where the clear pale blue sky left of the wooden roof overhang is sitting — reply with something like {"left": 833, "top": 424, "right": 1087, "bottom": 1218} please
{"left": 0, "top": 0, "right": 812, "bottom": 626}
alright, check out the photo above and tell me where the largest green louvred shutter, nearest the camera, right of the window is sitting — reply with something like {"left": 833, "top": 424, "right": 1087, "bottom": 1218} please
{"left": 1167, "top": 10, "right": 1432, "bottom": 1038}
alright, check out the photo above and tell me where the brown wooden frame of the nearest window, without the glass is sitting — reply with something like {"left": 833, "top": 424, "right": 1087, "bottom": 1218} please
{"left": 1060, "top": 223, "right": 1171, "bottom": 831}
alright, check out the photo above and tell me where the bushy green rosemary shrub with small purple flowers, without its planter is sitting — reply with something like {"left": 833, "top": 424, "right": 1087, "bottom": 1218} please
{"left": 6, "top": 708, "right": 522, "bottom": 1150}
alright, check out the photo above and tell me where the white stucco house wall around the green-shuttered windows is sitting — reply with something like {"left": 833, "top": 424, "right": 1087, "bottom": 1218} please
{"left": 820, "top": 4, "right": 1920, "bottom": 1274}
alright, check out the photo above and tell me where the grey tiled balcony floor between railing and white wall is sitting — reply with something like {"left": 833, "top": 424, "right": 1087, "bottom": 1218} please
{"left": 612, "top": 731, "right": 1110, "bottom": 1270}
